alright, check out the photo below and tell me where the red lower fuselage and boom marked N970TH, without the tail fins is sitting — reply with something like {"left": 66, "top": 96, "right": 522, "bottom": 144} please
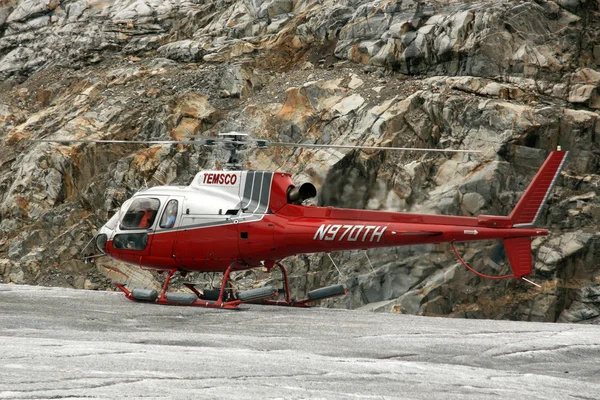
{"left": 107, "top": 205, "right": 547, "bottom": 271}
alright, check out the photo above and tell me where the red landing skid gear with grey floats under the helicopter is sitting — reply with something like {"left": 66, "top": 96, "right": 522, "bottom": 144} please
{"left": 115, "top": 262, "right": 348, "bottom": 310}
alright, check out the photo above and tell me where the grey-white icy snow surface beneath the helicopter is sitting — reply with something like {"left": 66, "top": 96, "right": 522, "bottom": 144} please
{"left": 0, "top": 285, "right": 600, "bottom": 399}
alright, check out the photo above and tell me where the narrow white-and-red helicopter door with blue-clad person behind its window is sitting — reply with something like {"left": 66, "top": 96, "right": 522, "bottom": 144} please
{"left": 150, "top": 196, "right": 183, "bottom": 262}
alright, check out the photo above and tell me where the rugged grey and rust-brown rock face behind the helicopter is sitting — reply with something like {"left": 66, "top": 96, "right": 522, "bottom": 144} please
{"left": 0, "top": 0, "right": 600, "bottom": 323}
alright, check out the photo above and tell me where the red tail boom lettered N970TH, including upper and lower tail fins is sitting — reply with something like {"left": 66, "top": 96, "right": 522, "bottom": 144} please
{"left": 274, "top": 151, "right": 567, "bottom": 279}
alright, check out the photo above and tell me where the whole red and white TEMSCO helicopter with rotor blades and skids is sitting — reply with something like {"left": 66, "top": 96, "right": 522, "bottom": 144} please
{"left": 31, "top": 132, "right": 568, "bottom": 309}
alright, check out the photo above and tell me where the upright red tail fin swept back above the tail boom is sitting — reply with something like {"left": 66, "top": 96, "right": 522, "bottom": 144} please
{"left": 507, "top": 151, "right": 569, "bottom": 227}
